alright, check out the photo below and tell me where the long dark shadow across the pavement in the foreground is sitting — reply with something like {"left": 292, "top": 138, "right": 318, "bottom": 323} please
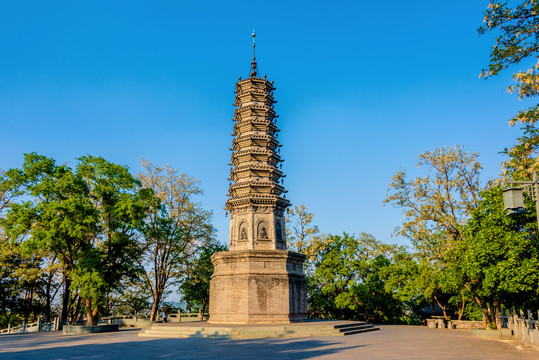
{"left": 0, "top": 335, "right": 365, "bottom": 360}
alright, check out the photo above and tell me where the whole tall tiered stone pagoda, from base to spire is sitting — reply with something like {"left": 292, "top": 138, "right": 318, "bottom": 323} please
{"left": 209, "top": 32, "right": 307, "bottom": 324}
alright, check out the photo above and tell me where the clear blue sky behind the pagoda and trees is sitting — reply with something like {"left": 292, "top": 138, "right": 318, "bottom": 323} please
{"left": 0, "top": 0, "right": 524, "bottom": 248}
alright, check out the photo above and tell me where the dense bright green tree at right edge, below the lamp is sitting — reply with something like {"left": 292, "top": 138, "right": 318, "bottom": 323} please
{"left": 447, "top": 187, "right": 539, "bottom": 328}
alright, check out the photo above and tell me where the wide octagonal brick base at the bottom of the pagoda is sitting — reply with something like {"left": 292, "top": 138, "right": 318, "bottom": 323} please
{"left": 208, "top": 250, "right": 307, "bottom": 324}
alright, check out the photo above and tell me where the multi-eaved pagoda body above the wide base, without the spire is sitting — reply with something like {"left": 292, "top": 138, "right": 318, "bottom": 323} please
{"left": 226, "top": 77, "right": 290, "bottom": 251}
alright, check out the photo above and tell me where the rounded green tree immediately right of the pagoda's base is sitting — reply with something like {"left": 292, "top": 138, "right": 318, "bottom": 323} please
{"left": 310, "top": 233, "right": 402, "bottom": 323}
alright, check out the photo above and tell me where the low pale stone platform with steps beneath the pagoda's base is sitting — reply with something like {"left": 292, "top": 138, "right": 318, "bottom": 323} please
{"left": 138, "top": 320, "right": 380, "bottom": 339}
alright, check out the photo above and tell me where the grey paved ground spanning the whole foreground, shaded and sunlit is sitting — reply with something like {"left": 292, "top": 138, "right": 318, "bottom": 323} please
{"left": 0, "top": 326, "right": 539, "bottom": 360}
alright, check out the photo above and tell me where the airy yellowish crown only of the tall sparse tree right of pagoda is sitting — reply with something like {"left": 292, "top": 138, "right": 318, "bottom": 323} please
{"left": 384, "top": 146, "right": 482, "bottom": 261}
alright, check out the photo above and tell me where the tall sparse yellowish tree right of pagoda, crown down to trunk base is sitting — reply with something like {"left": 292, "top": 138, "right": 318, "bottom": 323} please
{"left": 384, "top": 146, "right": 482, "bottom": 318}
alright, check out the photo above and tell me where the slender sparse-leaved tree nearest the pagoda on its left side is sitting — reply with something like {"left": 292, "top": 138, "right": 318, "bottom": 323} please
{"left": 138, "top": 159, "right": 215, "bottom": 321}
